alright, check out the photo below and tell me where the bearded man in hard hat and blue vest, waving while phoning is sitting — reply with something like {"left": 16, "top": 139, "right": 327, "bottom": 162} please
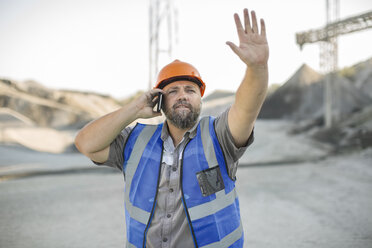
{"left": 75, "top": 9, "right": 269, "bottom": 248}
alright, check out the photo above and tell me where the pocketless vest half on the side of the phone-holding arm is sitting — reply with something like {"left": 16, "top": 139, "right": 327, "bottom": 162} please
{"left": 123, "top": 124, "right": 162, "bottom": 247}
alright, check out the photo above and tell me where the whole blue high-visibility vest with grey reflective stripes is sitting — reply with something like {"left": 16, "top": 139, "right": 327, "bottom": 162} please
{"left": 123, "top": 117, "right": 244, "bottom": 248}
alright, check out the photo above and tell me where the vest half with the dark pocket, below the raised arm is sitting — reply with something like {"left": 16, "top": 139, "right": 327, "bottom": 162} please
{"left": 181, "top": 118, "right": 243, "bottom": 247}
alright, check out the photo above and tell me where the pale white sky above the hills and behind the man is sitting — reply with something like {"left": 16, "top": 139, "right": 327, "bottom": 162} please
{"left": 0, "top": 0, "right": 372, "bottom": 98}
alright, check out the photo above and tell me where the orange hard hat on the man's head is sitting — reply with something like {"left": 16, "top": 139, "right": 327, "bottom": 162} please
{"left": 155, "top": 59, "right": 205, "bottom": 96}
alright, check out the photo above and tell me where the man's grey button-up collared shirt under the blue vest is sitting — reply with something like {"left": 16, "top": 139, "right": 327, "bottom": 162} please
{"left": 94, "top": 109, "right": 253, "bottom": 248}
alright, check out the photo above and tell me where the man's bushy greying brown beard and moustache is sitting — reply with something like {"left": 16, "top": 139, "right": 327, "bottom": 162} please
{"left": 164, "top": 101, "right": 201, "bottom": 129}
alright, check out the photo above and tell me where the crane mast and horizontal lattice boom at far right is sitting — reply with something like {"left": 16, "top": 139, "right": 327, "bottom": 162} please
{"left": 296, "top": 0, "right": 372, "bottom": 128}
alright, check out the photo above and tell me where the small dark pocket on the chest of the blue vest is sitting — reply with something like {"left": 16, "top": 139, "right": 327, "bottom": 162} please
{"left": 196, "top": 165, "right": 225, "bottom": 196}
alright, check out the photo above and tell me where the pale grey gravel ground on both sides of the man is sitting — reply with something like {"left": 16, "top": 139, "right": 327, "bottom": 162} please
{"left": 0, "top": 151, "right": 372, "bottom": 248}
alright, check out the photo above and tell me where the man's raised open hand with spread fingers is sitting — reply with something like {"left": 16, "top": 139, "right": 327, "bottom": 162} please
{"left": 226, "top": 9, "right": 269, "bottom": 67}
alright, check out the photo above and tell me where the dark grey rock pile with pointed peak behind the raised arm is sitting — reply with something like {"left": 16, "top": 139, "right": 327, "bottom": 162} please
{"left": 259, "top": 59, "right": 372, "bottom": 150}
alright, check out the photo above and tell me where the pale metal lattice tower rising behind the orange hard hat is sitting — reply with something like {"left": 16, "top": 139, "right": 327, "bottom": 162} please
{"left": 148, "top": 0, "right": 177, "bottom": 89}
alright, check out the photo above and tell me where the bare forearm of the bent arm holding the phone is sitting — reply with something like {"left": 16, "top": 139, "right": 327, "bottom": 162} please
{"left": 75, "top": 102, "right": 138, "bottom": 157}
